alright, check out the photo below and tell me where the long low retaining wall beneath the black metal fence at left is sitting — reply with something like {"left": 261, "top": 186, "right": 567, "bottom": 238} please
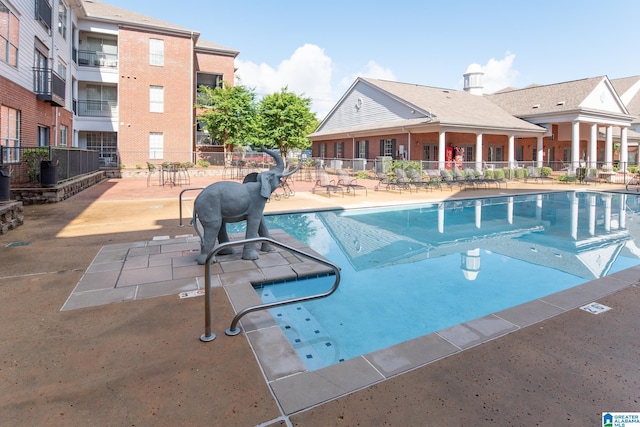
{"left": 10, "top": 171, "right": 106, "bottom": 205}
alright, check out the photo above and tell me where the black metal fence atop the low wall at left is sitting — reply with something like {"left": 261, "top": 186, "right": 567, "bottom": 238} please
{"left": 0, "top": 146, "right": 100, "bottom": 186}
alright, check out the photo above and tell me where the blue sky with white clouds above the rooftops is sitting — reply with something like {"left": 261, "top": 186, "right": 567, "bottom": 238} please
{"left": 103, "top": 0, "right": 640, "bottom": 120}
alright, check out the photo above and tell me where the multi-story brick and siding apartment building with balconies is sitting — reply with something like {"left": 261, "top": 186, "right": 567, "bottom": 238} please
{"left": 0, "top": 0, "right": 238, "bottom": 171}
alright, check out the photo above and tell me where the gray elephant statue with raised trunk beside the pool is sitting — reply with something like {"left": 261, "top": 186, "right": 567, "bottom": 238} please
{"left": 193, "top": 147, "right": 300, "bottom": 264}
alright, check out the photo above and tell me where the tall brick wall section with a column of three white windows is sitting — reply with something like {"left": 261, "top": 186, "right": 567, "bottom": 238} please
{"left": 118, "top": 28, "right": 194, "bottom": 167}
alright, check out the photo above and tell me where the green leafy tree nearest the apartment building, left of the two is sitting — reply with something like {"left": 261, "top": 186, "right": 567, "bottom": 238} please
{"left": 196, "top": 82, "right": 257, "bottom": 161}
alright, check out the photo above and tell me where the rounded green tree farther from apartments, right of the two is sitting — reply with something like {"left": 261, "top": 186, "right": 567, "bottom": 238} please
{"left": 258, "top": 87, "right": 318, "bottom": 159}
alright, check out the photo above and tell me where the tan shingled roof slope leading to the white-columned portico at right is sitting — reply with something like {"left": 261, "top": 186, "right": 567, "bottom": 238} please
{"left": 486, "top": 76, "right": 606, "bottom": 117}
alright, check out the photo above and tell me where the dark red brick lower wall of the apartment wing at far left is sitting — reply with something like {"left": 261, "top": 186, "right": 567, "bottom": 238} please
{"left": 0, "top": 76, "right": 73, "bottom": 147}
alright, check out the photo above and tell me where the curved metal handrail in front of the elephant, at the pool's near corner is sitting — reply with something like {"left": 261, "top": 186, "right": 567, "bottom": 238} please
{"left": 200, "top": 237, "right": 340, "bottom": 342}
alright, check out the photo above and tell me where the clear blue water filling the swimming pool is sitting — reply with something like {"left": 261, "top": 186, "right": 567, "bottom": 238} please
{"left": 248, "top": 192, "right": 640, "bottom": 370}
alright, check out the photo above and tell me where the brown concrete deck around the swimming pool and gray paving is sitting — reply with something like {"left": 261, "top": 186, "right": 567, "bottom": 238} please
{"left": 0, "top": 178, "right": 640, "bottom": 426}
